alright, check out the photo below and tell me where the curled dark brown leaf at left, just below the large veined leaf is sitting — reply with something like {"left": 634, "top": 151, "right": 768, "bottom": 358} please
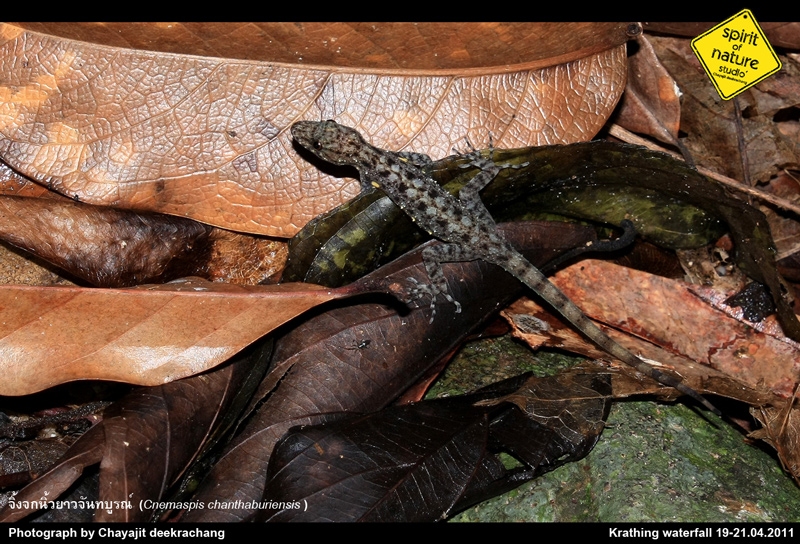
{"left": 0, "top": 196, "right": 287, "bottom": 287}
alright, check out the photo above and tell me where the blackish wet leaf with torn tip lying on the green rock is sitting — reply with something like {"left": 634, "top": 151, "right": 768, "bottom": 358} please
{"left": 258, "top": 373, "right": 611, "bottom": 522}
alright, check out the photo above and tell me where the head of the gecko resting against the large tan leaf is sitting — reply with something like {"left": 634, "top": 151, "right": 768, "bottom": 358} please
{"left": 292, "top": 121, "right": 367, "bottom": 164}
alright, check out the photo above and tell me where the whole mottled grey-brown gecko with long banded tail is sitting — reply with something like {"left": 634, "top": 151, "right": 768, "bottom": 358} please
{"left": 291, "top": 121, "right": 721, "bottom": 415}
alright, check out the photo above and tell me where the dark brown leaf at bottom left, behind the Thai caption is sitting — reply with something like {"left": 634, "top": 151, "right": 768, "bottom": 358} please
{"left": 0, "top": 344, "right": 271, "bottom": 522}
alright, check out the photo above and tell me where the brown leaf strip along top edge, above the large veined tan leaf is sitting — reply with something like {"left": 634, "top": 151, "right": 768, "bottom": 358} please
{"left": 7, "top": 22, "right": 640, "bottom": 70}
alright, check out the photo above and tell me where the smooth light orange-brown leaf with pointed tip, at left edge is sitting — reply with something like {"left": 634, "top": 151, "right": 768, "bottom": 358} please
{"left": 0, "top": 279, "right": 353, "bottom": 395}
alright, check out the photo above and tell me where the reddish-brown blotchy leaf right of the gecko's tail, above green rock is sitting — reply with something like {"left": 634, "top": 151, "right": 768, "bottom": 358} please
{"left": 504, "top": 260, "right": 800, "bottom": 403}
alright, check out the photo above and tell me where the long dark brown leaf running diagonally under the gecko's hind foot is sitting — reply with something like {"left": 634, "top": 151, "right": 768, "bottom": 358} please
{"left": 185, "top": 221, "right": 592, "bottom": 521}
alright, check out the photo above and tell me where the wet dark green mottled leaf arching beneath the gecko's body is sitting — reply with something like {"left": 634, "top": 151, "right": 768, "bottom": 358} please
{"left": 285, "top": 141, "right": 800, "bottom": 340}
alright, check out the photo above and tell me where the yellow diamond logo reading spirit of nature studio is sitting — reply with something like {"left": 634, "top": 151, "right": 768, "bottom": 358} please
{"left": 692, "top": 9, "right": 781, "bottom": 100}
